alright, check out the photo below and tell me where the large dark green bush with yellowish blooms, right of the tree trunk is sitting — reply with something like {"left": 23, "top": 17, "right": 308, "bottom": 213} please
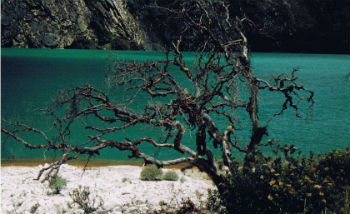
{"left": 219, "top": 146, "right": 350, "bottom": 213}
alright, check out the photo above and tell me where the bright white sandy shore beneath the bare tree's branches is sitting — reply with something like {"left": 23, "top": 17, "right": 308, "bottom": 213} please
{"left": 1, "top": 164, "right": 214, "bottom": 214}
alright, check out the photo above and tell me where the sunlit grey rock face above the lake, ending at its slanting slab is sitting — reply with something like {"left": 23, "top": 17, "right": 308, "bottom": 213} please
{"left": 1, "top": 0, "right": 156, "bottom": 49}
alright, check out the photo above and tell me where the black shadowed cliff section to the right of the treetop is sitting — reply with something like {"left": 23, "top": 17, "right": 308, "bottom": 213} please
{"left": 244, "top": 0, "right": 350, "bottom": 54}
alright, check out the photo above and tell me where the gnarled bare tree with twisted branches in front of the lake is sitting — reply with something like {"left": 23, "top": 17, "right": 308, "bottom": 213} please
{"left": 1, "top": 0, "right": 313, "bottom": 191}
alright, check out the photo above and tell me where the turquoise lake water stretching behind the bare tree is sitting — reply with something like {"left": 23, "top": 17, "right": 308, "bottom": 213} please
{"left": 1, "top": 49, "right": 350, "bottom": 160}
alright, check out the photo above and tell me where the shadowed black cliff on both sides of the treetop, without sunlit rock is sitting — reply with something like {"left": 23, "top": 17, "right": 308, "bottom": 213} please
{"left": 129, "top": 0, "right": 350, "bottom": 54}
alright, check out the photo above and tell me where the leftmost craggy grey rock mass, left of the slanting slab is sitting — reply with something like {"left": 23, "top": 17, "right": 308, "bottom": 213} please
{"left": 1, "top": 0, "right": 91, "bottom": 48}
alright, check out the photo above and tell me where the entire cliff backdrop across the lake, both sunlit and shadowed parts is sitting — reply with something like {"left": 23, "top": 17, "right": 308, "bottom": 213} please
{"left": 1, "top": 0, "right": 350, "bottom": 53}
